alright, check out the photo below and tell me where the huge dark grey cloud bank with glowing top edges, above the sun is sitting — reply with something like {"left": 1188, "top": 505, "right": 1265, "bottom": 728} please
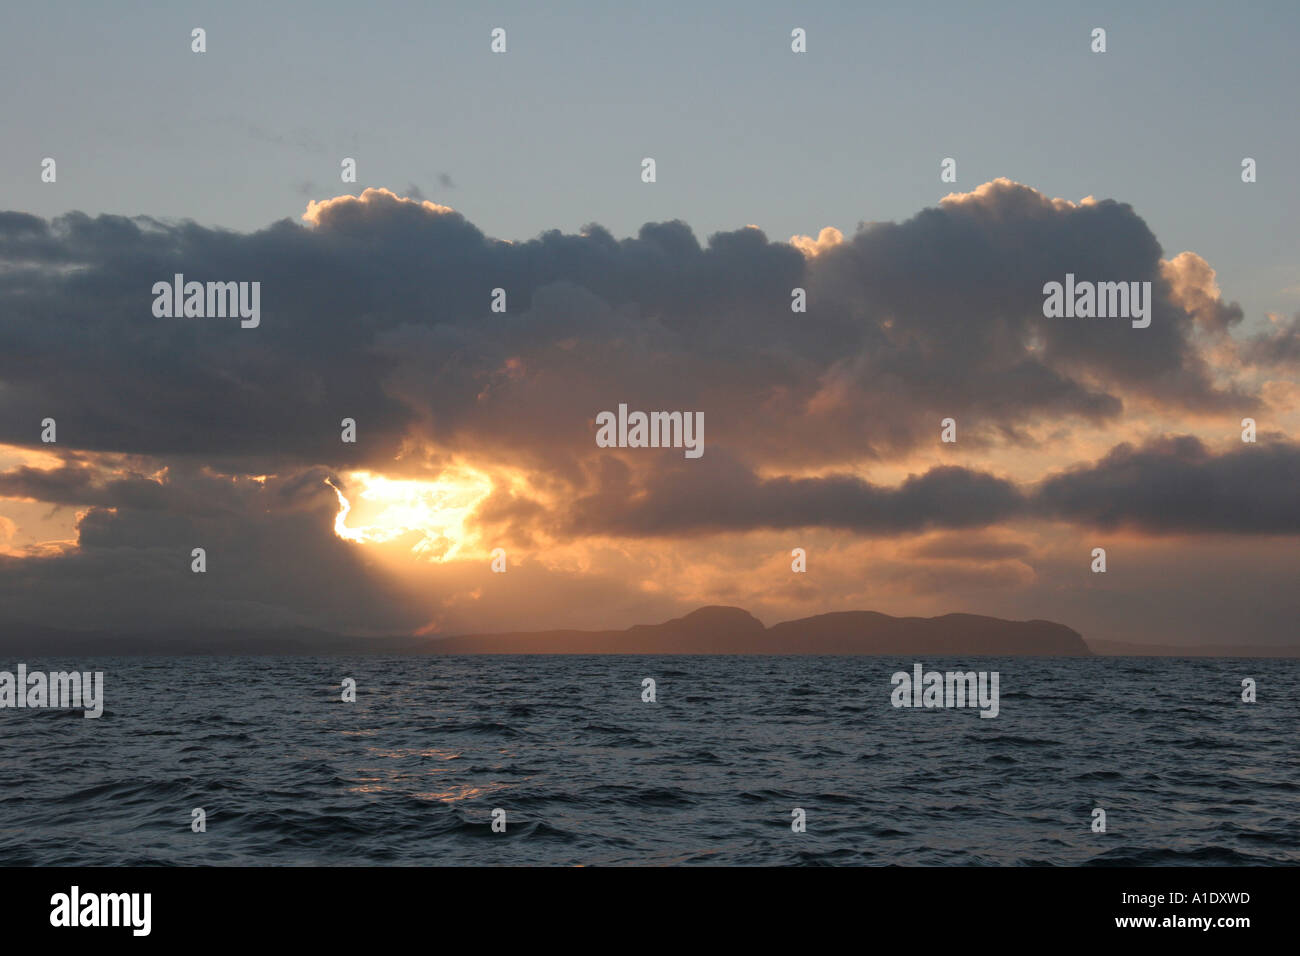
{"left": 0, "top": 182, "right": 1256, "bottom": 471}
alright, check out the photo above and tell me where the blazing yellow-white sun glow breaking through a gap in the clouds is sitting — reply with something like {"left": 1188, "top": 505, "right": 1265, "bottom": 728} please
{"left": 325, "top": 466, "right": 493, "bottom": 562}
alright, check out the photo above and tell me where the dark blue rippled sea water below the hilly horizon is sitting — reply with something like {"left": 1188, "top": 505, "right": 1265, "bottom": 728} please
{"left": 0, "top": 657, "right": 1300, "bottom": 865}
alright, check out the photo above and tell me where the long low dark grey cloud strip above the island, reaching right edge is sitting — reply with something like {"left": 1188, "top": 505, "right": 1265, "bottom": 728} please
{"left": 556, "top": 436, "right": 1300, "bottom": 541}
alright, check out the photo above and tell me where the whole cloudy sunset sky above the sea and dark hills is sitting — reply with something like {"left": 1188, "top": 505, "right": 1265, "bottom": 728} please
{"left": 0, "top": 3, "right": 1300, "bottom": 644}
